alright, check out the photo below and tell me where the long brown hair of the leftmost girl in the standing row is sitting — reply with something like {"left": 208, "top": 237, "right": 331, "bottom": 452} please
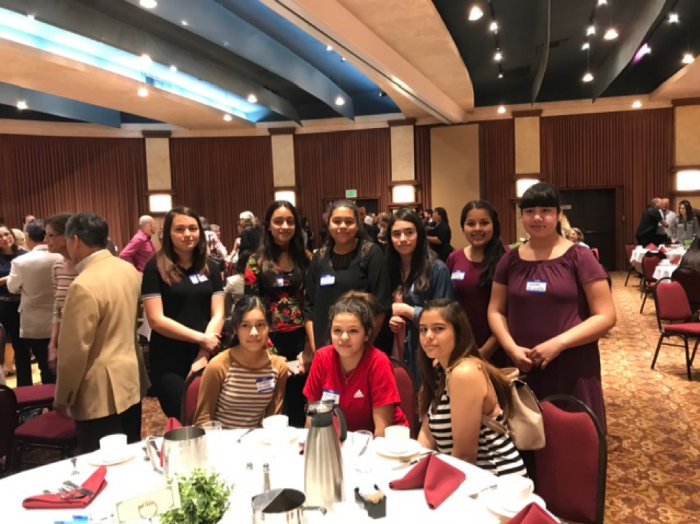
{"left": 155, "top": 206, "right": 209, "bottom": 285}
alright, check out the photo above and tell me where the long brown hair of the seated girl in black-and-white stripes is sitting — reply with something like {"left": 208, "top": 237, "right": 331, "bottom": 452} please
{"left": 418, "top": 298, "right": 512, "bottom": 418}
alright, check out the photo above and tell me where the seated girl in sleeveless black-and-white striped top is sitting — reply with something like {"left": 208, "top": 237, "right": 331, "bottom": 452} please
{"left": 418, "top": 299, "right": 527, "bottom": 475}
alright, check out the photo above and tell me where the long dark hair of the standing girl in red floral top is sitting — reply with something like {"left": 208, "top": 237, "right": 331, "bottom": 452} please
{"left": 257, "top": 200, "right": 309, "bottom": 291}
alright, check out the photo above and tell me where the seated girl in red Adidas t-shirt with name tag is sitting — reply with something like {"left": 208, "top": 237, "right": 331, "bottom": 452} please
{"left": 304, "top": 291, "right": 408, "bottom": 437}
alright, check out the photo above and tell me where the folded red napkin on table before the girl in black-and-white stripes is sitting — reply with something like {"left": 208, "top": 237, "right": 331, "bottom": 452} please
{"left": 389, "top": 454, "right": 467, "bottom": 509}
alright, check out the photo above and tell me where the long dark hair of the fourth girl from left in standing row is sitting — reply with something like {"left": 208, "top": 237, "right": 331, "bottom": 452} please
{"left": 386, "top": 207, "right": 437, "bottom": 293}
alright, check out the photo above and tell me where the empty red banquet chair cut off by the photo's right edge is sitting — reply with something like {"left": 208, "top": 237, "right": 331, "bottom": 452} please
{"left": 651, "top": 278, "right": 700, "bottom": 380}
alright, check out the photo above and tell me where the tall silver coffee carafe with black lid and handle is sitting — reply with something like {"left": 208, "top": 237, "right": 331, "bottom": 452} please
{"left": 304, "top": 402, "right": 347, "bottom": 510}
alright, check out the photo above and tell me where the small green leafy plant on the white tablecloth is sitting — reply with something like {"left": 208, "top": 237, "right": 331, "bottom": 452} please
{"left": 160, "top": 469, "right": 233, "bottom": 524}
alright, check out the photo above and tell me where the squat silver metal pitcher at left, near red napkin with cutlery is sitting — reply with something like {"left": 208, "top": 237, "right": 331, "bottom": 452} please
{"left": 146, "top": 426, "right": 207, "bottom": 477}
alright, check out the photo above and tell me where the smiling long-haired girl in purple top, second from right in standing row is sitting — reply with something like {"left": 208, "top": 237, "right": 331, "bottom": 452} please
{"left": 447, "top": 200, "right": 507, "bottom": 367}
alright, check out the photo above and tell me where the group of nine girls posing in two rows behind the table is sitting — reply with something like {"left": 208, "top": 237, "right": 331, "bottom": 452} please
{"left": 143, "top": 184, "right": 615, "bottom": 474}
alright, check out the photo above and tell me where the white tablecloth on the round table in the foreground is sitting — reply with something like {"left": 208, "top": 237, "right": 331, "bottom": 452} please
{"left": 0, "top": 430, "right": 516, "bottom": 524}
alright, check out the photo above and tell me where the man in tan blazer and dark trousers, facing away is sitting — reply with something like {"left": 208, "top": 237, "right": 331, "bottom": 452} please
{"left": 54, "top": 213, "right": 149, "bottom": 453}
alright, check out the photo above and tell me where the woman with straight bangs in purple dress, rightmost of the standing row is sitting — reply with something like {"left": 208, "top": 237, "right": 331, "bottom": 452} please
{"left": 488, "top": 183, "right": 616, "bottom": 427}
